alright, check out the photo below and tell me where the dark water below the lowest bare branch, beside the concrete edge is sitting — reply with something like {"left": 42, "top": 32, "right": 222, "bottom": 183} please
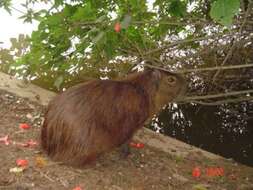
{"left": 152, "top": 102, "right": 253, "bottom": 166}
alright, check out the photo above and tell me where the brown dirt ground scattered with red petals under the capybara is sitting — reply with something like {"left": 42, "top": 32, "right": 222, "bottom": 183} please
{"left": 0, "top": 90, "right": 253, "bottom": 190}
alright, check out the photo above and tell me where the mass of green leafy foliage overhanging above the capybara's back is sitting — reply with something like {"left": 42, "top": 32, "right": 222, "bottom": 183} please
{"left": 0, "top": 0, "right": 245, "bottom": 89}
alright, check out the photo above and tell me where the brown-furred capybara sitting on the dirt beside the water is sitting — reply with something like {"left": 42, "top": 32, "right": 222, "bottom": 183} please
{"left": 41, "top": 69, "right": 185, "bottom": 167}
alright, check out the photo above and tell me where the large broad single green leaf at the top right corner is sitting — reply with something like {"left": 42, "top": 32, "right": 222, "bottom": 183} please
{"left": 210, "top": 0, "right": 240, "bottom": 26}
